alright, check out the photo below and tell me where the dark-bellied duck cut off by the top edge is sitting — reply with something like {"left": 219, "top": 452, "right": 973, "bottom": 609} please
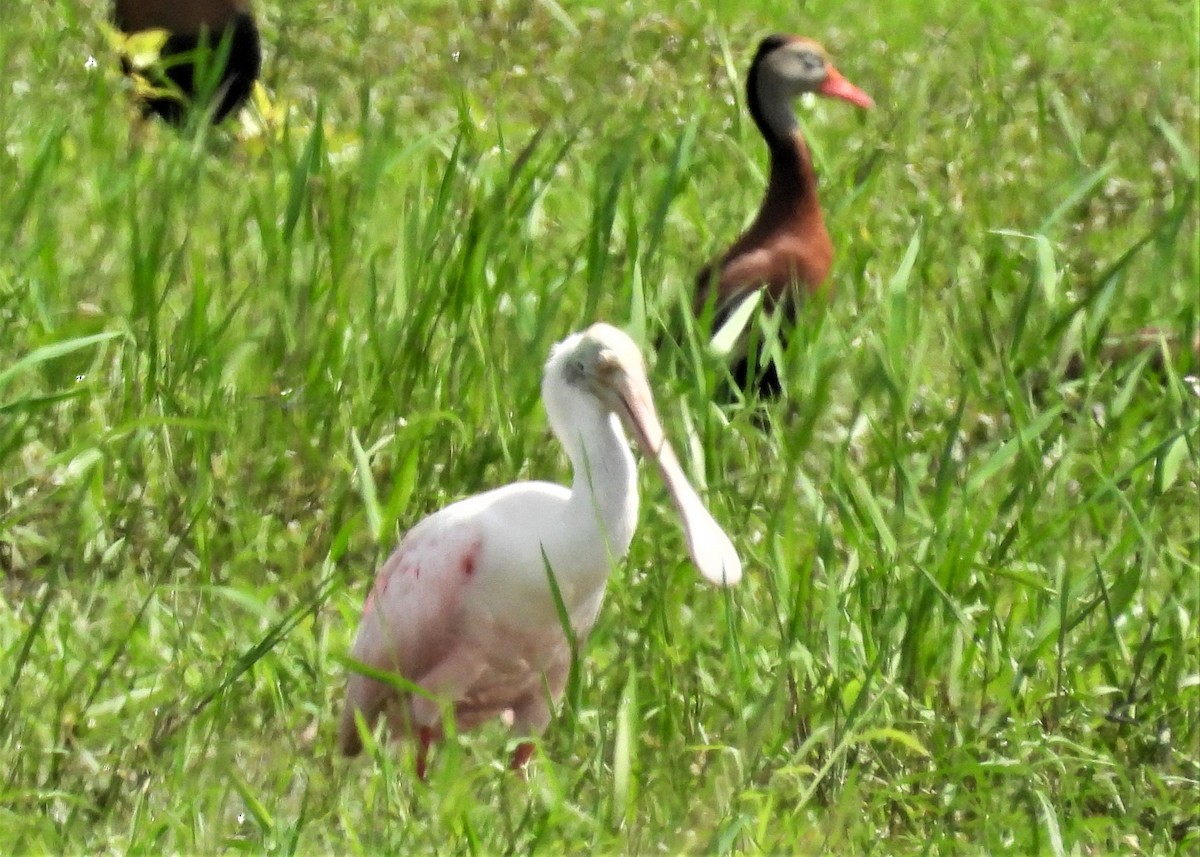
{"left": 113, "top": 0, "right": 263, "bottom": 124}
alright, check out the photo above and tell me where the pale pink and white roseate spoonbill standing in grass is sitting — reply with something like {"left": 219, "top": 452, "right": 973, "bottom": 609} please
{"left": 338, "top": 324, "right": 742, "bottom": 779}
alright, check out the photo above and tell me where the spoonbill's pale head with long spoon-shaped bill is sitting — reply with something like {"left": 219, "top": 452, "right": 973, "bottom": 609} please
{"left": 542, "top": 323, "right": 742, "bottom": 586}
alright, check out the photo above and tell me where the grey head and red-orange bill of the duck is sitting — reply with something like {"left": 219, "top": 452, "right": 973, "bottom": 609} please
{"left": 750, "top": 34, "right": 875, "bottom": 108}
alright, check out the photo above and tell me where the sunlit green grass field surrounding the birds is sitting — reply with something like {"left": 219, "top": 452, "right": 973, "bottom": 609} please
{"left": 0, "top": 0, "right": 1200, "bottom": 855}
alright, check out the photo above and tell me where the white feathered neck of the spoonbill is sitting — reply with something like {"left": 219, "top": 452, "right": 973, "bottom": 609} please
{"left": 558, "top": 398, "right": 637, "bottom": 559}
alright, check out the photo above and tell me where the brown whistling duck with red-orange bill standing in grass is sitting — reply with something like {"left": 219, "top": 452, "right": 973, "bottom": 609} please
{"left": 694, "top": 35, "right": 872, "bottom": 395}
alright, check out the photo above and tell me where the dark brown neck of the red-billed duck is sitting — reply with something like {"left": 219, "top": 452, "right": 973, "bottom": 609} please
{"left": 748, "top": 79, "right": 823, "bottom": 222}
